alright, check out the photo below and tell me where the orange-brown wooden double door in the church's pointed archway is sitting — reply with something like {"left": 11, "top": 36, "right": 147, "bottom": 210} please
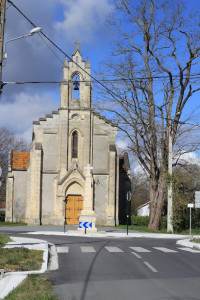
{"left": 65, "top": 195, "right": 83, "bottom": 225}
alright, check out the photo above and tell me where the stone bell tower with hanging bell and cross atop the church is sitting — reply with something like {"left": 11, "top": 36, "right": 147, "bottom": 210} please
{"left": 60, "top": 41, "right": 92, "bottom": 109}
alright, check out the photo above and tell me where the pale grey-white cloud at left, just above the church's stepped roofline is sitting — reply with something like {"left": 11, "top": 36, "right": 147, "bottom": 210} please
{"left": 0, "top": 92, "right": 58, "bottom": 143}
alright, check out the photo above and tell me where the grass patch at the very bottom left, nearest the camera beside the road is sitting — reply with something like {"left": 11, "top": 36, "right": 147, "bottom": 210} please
{"left": 4, "top": 275, "right": 59, "bottom": 300}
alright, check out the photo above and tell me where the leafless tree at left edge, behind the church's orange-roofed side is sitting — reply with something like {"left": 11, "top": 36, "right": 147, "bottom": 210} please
{"left": 0, "top": 128, "right": 28, "bottom": 202}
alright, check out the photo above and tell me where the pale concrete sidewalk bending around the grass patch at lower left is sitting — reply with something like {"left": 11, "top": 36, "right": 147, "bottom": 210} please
{"left": 0, "top": 236, "right": 48, "bottom": 299}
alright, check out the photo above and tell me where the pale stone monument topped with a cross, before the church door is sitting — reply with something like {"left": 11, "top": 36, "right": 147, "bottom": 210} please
{"left": 78, "top": 164, "right": 97, "bottom": 232}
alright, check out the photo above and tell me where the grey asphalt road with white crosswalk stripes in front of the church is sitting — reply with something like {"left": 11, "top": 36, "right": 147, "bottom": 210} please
{"left": 2, "top": 232, "right": 200, "bottom": 300}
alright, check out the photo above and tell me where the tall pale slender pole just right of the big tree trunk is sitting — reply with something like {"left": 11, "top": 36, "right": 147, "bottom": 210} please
{"left": 167, "top": 119, "right": 173, "bottom": 233}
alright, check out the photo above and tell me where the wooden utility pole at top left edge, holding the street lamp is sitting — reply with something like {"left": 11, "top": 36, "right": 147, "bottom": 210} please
{"left": 0, "top": 0, "right": 6, "bottom": 94}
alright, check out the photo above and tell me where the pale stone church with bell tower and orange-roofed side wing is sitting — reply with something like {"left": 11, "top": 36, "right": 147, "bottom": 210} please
{"left": 6, "top": 43, "right": 130, "bottom": 231}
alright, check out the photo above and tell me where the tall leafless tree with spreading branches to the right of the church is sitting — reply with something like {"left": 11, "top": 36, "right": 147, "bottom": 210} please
{"left": 95, "top": 0, "right": 200, "bottom": 230}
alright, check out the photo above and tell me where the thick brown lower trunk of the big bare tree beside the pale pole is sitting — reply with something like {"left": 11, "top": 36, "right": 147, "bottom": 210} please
{"left": 148, "top": 172, "right": 166, "bottom": 231}
